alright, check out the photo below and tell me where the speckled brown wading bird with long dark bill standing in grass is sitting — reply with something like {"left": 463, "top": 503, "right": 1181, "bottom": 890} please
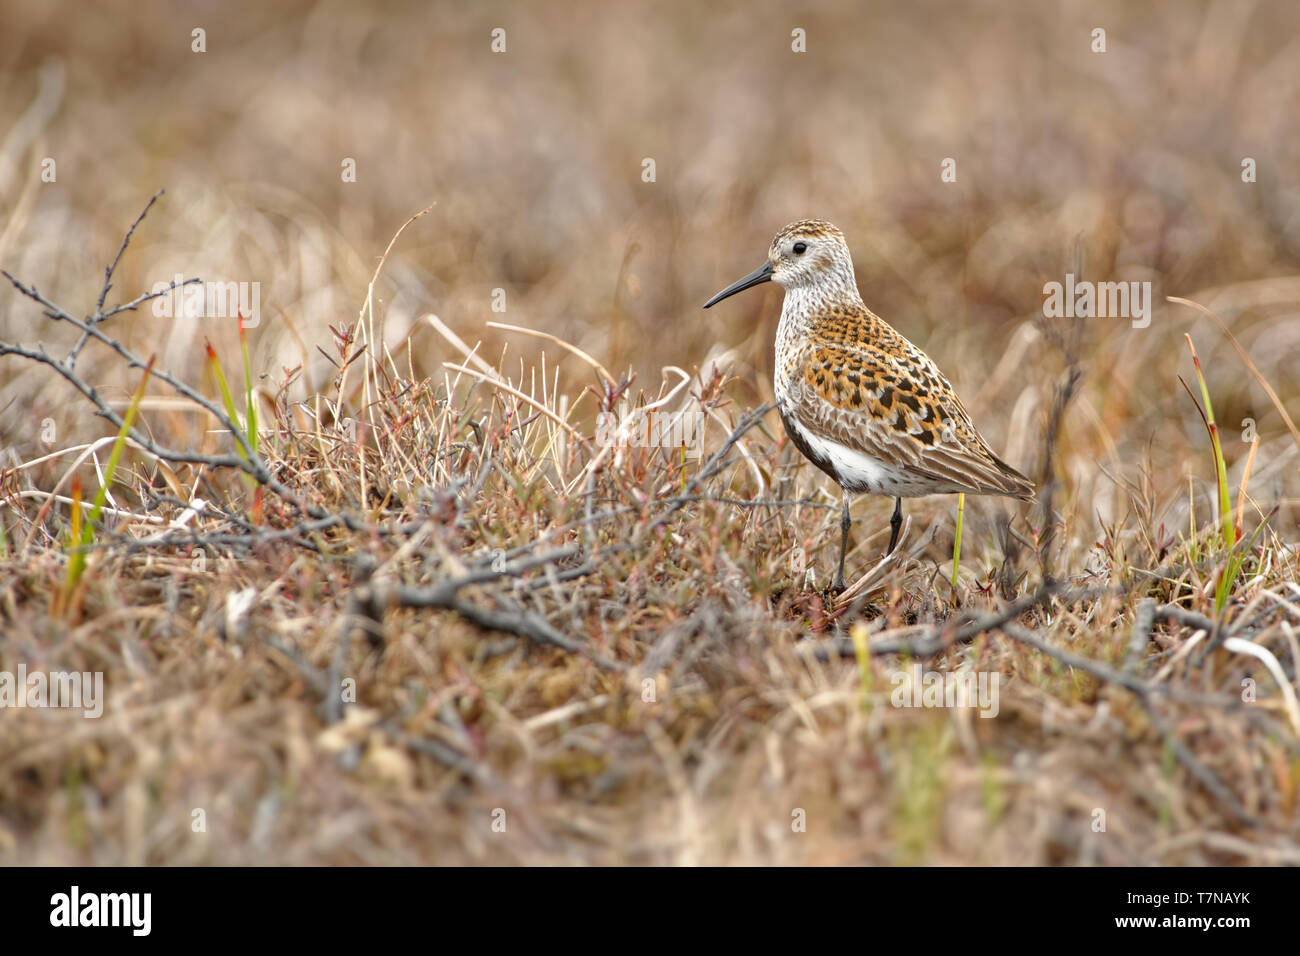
{"left": 705, "top": 219, "right": 1034, "bottom": 593}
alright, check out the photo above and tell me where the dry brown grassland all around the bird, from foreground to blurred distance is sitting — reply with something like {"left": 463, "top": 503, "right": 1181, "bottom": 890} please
{"left": 0, "top": 3, "right": 1300, "bottom": 864}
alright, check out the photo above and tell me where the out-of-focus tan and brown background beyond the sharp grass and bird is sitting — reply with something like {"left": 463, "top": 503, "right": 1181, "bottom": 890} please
{"left": 0, "top": 0, "right": 1300, "bottom": 540}
